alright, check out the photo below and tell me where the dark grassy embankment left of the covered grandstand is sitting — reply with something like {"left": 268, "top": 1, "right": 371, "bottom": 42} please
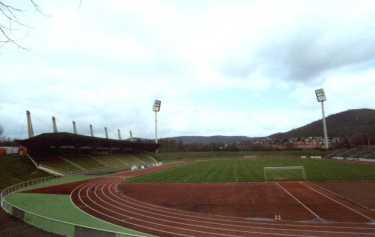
{"left": 0, "top": 155, "right": 49, "bottom": 190}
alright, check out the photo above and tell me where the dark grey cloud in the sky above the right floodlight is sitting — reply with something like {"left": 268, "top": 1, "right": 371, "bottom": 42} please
{"left": 222, "top": 17, "right": 375, "bottom": 81}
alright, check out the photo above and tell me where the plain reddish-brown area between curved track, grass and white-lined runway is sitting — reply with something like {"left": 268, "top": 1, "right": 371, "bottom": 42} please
{"left": 120, "top": 183, "right": 313, "bottom": 220}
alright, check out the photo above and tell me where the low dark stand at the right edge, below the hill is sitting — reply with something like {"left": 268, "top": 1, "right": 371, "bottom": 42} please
{"left": 326, "top": 146, "right": 375, "bottom": 161}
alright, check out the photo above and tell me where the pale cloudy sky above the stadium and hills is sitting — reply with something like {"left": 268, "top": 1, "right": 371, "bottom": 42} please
{"left": 0, "top": 0, "right": 375, "bottom": 138}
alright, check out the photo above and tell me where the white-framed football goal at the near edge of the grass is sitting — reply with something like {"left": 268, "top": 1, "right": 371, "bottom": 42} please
{"left": 264, "top": 166, "right": 306, "bottom": 181}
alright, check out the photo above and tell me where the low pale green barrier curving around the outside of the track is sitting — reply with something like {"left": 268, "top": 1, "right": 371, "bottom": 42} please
{"left": 0, "top": 176, "right": 151, "bottom": 237}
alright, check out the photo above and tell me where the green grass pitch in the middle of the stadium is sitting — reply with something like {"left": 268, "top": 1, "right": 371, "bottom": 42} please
{"left": 129, "top": 153, "right": 375, "bottom": 183}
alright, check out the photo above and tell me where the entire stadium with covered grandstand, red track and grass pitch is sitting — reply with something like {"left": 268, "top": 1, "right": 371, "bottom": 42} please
{"left": 1, "top": 108, "right": 375, "bottom": 237}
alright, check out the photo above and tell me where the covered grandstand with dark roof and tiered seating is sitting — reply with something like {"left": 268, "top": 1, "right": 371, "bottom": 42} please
{"left": 17, "top": 133, "right": 159, "bottom": 175}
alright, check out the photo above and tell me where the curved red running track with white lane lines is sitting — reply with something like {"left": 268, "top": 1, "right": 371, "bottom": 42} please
{"left": 71, "top": 176, "right": 375, "bottom": 237}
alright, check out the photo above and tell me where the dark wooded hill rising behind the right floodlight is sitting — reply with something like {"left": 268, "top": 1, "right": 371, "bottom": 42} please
{"left": 270, "top": 109, "right": 375, "bottom": 139}
